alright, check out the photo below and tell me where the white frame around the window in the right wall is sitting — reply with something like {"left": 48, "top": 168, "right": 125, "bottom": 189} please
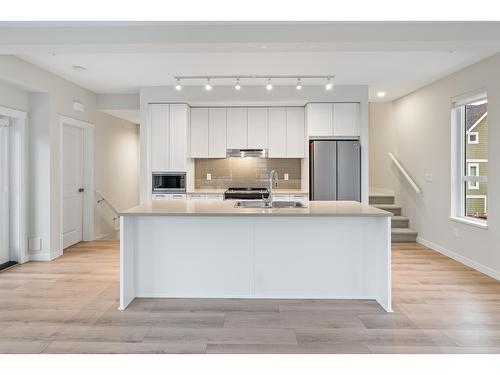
{"left": 450, "top": 89, "right": 489, "bottom": 229}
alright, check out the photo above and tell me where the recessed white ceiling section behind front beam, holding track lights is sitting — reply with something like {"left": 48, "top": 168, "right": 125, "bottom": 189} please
{"left": 21, "top": 51, "right": 491, "bottom": 100}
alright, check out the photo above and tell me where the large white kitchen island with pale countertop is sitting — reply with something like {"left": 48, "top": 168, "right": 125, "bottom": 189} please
{"left": 120, "top": 200, "right": 391, "bottom": 311}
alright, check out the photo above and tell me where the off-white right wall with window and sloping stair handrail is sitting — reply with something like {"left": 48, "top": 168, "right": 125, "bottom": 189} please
{"left": 370, "top": 54, "right": 500, "bottom": 278}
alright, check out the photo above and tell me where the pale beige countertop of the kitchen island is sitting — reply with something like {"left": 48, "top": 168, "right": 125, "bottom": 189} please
{"left": 119, "top": 200, "right": 392, "bottom": 217}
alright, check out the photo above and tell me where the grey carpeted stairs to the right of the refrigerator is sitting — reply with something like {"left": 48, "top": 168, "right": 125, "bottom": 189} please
{"left": 370, "top": 192, "right": 418, "bottom": 242}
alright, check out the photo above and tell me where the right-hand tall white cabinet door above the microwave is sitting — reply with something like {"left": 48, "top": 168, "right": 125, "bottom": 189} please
{"left": 169, "top": 104, "right": 189, "bottom": 172}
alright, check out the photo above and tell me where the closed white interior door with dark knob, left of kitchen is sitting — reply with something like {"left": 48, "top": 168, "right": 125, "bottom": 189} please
{"left": 63, "top": 125, "right": 83, "bottom": 248}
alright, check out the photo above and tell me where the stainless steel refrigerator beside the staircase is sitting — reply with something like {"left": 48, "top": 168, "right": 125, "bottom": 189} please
{"left": 309, "top": 140, "right": 361, "bottom": 202}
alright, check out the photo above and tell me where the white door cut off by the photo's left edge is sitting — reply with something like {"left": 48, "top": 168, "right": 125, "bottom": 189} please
{"left": 0, "top": 117, "right": 10, "bottom": 265}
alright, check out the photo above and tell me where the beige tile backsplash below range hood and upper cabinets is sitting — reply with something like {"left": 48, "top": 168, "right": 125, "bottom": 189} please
{"left": 194, "top": 158, "right": 301, "bottom": 189}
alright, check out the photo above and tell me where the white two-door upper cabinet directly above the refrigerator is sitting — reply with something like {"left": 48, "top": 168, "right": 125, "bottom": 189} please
{"left": 306, "top": 103, "right": 360, "bottom": 137}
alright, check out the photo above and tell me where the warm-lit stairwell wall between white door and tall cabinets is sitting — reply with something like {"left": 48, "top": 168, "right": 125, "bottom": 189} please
{"left": 94, "top": 112, "right": 139, "bottom": 239}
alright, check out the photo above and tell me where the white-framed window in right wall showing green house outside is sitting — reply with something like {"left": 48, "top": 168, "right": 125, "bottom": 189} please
{"left": 452, "top": 93, "right": 488, "bottom": 227}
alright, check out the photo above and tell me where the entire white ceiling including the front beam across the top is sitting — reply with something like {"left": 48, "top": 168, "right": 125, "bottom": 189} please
{"left": 0, "top": 22, "right": 500, "bottom": 100}
